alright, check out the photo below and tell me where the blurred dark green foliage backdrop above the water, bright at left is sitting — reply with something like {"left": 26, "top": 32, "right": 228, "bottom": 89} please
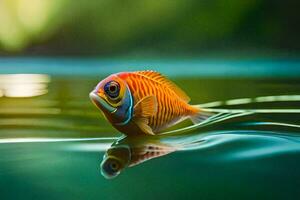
{"left": 0, "top": 0, "right": 300, "bottom": 56}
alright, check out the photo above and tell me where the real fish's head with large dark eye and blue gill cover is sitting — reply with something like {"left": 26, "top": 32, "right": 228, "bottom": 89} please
{"left": 90, "top": 75, "right": 133, "bottom": 123}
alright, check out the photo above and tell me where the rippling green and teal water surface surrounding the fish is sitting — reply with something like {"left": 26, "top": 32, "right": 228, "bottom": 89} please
{"left": 0, "top": 59, "right": 300, "bottom": 200}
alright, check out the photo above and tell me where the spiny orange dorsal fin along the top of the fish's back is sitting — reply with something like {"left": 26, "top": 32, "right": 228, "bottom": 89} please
{"left": 135, "top": 70, "right": 190, "bottom": 102}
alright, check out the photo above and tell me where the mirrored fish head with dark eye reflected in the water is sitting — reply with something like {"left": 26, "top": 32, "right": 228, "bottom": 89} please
{"left": 101, "top": 145, "right": 131, "bottom": 179}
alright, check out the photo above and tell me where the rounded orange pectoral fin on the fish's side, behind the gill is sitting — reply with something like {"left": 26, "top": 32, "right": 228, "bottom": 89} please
{"left": 133, "top": 95, "right": 157, "bottom": 118}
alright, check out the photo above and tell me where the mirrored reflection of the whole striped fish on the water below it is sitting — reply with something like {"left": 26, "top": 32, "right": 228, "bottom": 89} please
{"left": 101, "top": 136, "right": 181, "bottom": 179}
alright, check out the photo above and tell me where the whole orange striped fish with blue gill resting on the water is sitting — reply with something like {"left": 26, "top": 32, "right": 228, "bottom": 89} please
{"left": 89, "top": 70, "right": 212, "bottom": 135}
